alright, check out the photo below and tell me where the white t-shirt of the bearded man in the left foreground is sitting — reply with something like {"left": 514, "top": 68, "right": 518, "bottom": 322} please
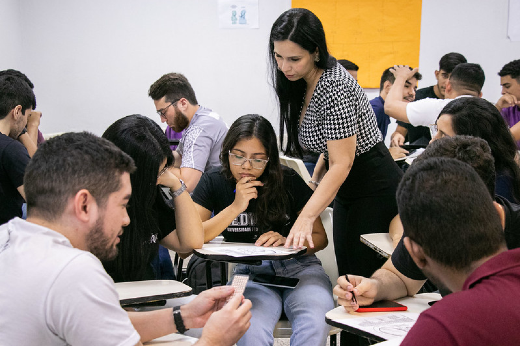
{"left": 0, "top": 218, "right": 140, "bottom": 346}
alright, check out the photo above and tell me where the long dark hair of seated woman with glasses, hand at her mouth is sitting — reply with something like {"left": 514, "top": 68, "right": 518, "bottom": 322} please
{"left": 220, "top": 114, "right": 288, "bottom": 233}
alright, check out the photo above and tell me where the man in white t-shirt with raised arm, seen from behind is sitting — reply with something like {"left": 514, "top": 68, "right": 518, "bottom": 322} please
{"left": 385, "top": 63, "right": 485, "bottom": 133}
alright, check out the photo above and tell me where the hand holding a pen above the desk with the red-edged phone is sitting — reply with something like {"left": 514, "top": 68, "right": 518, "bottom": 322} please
{"left": 333, "top": 275, "right": 377, "bottom": 311}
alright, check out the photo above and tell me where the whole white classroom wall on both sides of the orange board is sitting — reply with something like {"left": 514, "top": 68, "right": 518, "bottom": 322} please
{"left": 0, "top": 0, "right": 520, "bottom": 134}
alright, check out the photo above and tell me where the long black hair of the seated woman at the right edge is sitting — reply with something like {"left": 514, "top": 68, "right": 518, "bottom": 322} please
{"left": 439, "top": 97, "right": 520, "bottom": 203}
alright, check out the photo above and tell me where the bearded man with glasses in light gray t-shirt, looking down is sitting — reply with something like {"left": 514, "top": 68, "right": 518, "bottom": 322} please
{"left": 148, "top": 73, "right": 228, "bottom": 192}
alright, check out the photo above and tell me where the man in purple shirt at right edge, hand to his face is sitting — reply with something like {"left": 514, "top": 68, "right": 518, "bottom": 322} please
{"left": 495, "top": 59, "right": 520, "bottom": 149}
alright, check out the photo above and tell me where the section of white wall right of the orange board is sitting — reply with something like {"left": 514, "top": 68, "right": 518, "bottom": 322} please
{"left": 419, "top": 0, "right": 520, "bottom": 103}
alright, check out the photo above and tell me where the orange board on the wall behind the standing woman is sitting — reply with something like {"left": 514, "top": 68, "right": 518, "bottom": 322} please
{"left": 292, "top": 0, "right": 422, "bottom": 88}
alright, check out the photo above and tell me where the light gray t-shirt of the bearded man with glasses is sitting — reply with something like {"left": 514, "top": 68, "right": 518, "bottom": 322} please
{"left": 177, "top": 106, "right": 228, "bottom": 172}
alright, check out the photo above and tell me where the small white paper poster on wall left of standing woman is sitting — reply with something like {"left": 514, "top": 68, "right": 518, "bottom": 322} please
{"left": 218, "top": 0, "right": 258, "bottom": 29}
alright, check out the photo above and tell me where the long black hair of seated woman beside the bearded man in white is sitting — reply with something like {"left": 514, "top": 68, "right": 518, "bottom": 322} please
{"left": 103, "top": 114, "right": 175, "bottom": 281}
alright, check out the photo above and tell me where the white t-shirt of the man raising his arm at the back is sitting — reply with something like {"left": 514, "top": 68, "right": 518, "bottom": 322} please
{"left": 406, "top": 95, "right": 471, "bottom": 126}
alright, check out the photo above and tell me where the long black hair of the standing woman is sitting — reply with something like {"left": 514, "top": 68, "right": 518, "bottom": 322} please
{"left": 269, "top": 8, "right": 336, "bottom": 157}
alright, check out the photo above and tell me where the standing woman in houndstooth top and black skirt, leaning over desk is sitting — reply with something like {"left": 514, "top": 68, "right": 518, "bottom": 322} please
{"left": 269, "top": 8, "right": 402, "bottom": 276}
